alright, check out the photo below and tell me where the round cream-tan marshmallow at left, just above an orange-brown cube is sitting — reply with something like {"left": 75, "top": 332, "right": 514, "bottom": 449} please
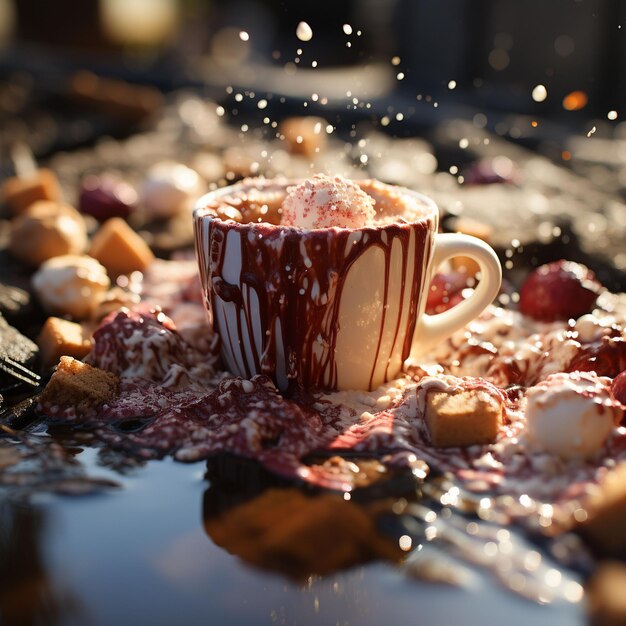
{"left": 32, "top": 254, "right": 111, "bottom": 320}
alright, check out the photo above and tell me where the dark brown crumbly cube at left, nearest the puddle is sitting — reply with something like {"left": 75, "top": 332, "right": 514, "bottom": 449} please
{"left": 39, "top": 356, "right": 119, "bottom": 413}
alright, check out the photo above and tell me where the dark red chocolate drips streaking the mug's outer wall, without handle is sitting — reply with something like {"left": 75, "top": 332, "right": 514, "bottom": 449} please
{"left": 195, "top": 178, "right": 436, "bottom": 390}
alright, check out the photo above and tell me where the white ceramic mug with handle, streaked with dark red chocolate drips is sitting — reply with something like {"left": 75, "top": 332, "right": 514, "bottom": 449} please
{"left": 194, "top": 179, "right": 502, "bottom": 390}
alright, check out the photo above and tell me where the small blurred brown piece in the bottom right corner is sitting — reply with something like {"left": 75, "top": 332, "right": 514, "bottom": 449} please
{"left": 587, "top": 561, "right": 626, "bottom": 626}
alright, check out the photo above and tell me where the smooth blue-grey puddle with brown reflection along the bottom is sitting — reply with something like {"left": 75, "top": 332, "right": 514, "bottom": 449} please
{"left": 0, "top": 435, "right": 584, "bottom": 626}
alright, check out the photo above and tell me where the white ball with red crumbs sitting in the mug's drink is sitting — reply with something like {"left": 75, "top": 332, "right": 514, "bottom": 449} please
{"left": 282, "top": 174, "right": 376, "bottom": 229}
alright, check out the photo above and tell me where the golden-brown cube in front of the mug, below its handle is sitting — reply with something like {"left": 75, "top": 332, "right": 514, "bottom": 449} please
{"left": 425, "top": 389, "right": 503, "bottom": 448}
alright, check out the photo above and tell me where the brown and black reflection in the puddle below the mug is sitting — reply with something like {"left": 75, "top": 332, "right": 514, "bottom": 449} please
{"left": 203, "top": 450, "right": 403, "bottom": 581}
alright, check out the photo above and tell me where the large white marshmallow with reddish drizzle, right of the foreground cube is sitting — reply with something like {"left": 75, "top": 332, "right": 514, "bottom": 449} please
{"left": 526, "top": 372, "right": 622, "bottom": 458}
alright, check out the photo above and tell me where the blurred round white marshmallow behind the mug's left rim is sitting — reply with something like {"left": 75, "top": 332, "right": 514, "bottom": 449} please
{"left": 140, "top": 161, "right": 206, "bottom": 219}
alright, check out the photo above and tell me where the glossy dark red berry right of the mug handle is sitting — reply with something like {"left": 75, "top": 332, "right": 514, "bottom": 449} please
{"left": 519, "top": 261, "right": 602, "bottom": 322}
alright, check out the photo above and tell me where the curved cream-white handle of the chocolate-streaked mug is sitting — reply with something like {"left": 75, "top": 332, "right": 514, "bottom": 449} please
{"left": 411, "top": 233, "right": 502, "bottom": 355}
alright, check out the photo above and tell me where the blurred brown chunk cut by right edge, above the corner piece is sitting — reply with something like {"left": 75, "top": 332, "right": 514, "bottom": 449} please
{"left": 577, "top": 463, "right": 626, "bottom": 558}
